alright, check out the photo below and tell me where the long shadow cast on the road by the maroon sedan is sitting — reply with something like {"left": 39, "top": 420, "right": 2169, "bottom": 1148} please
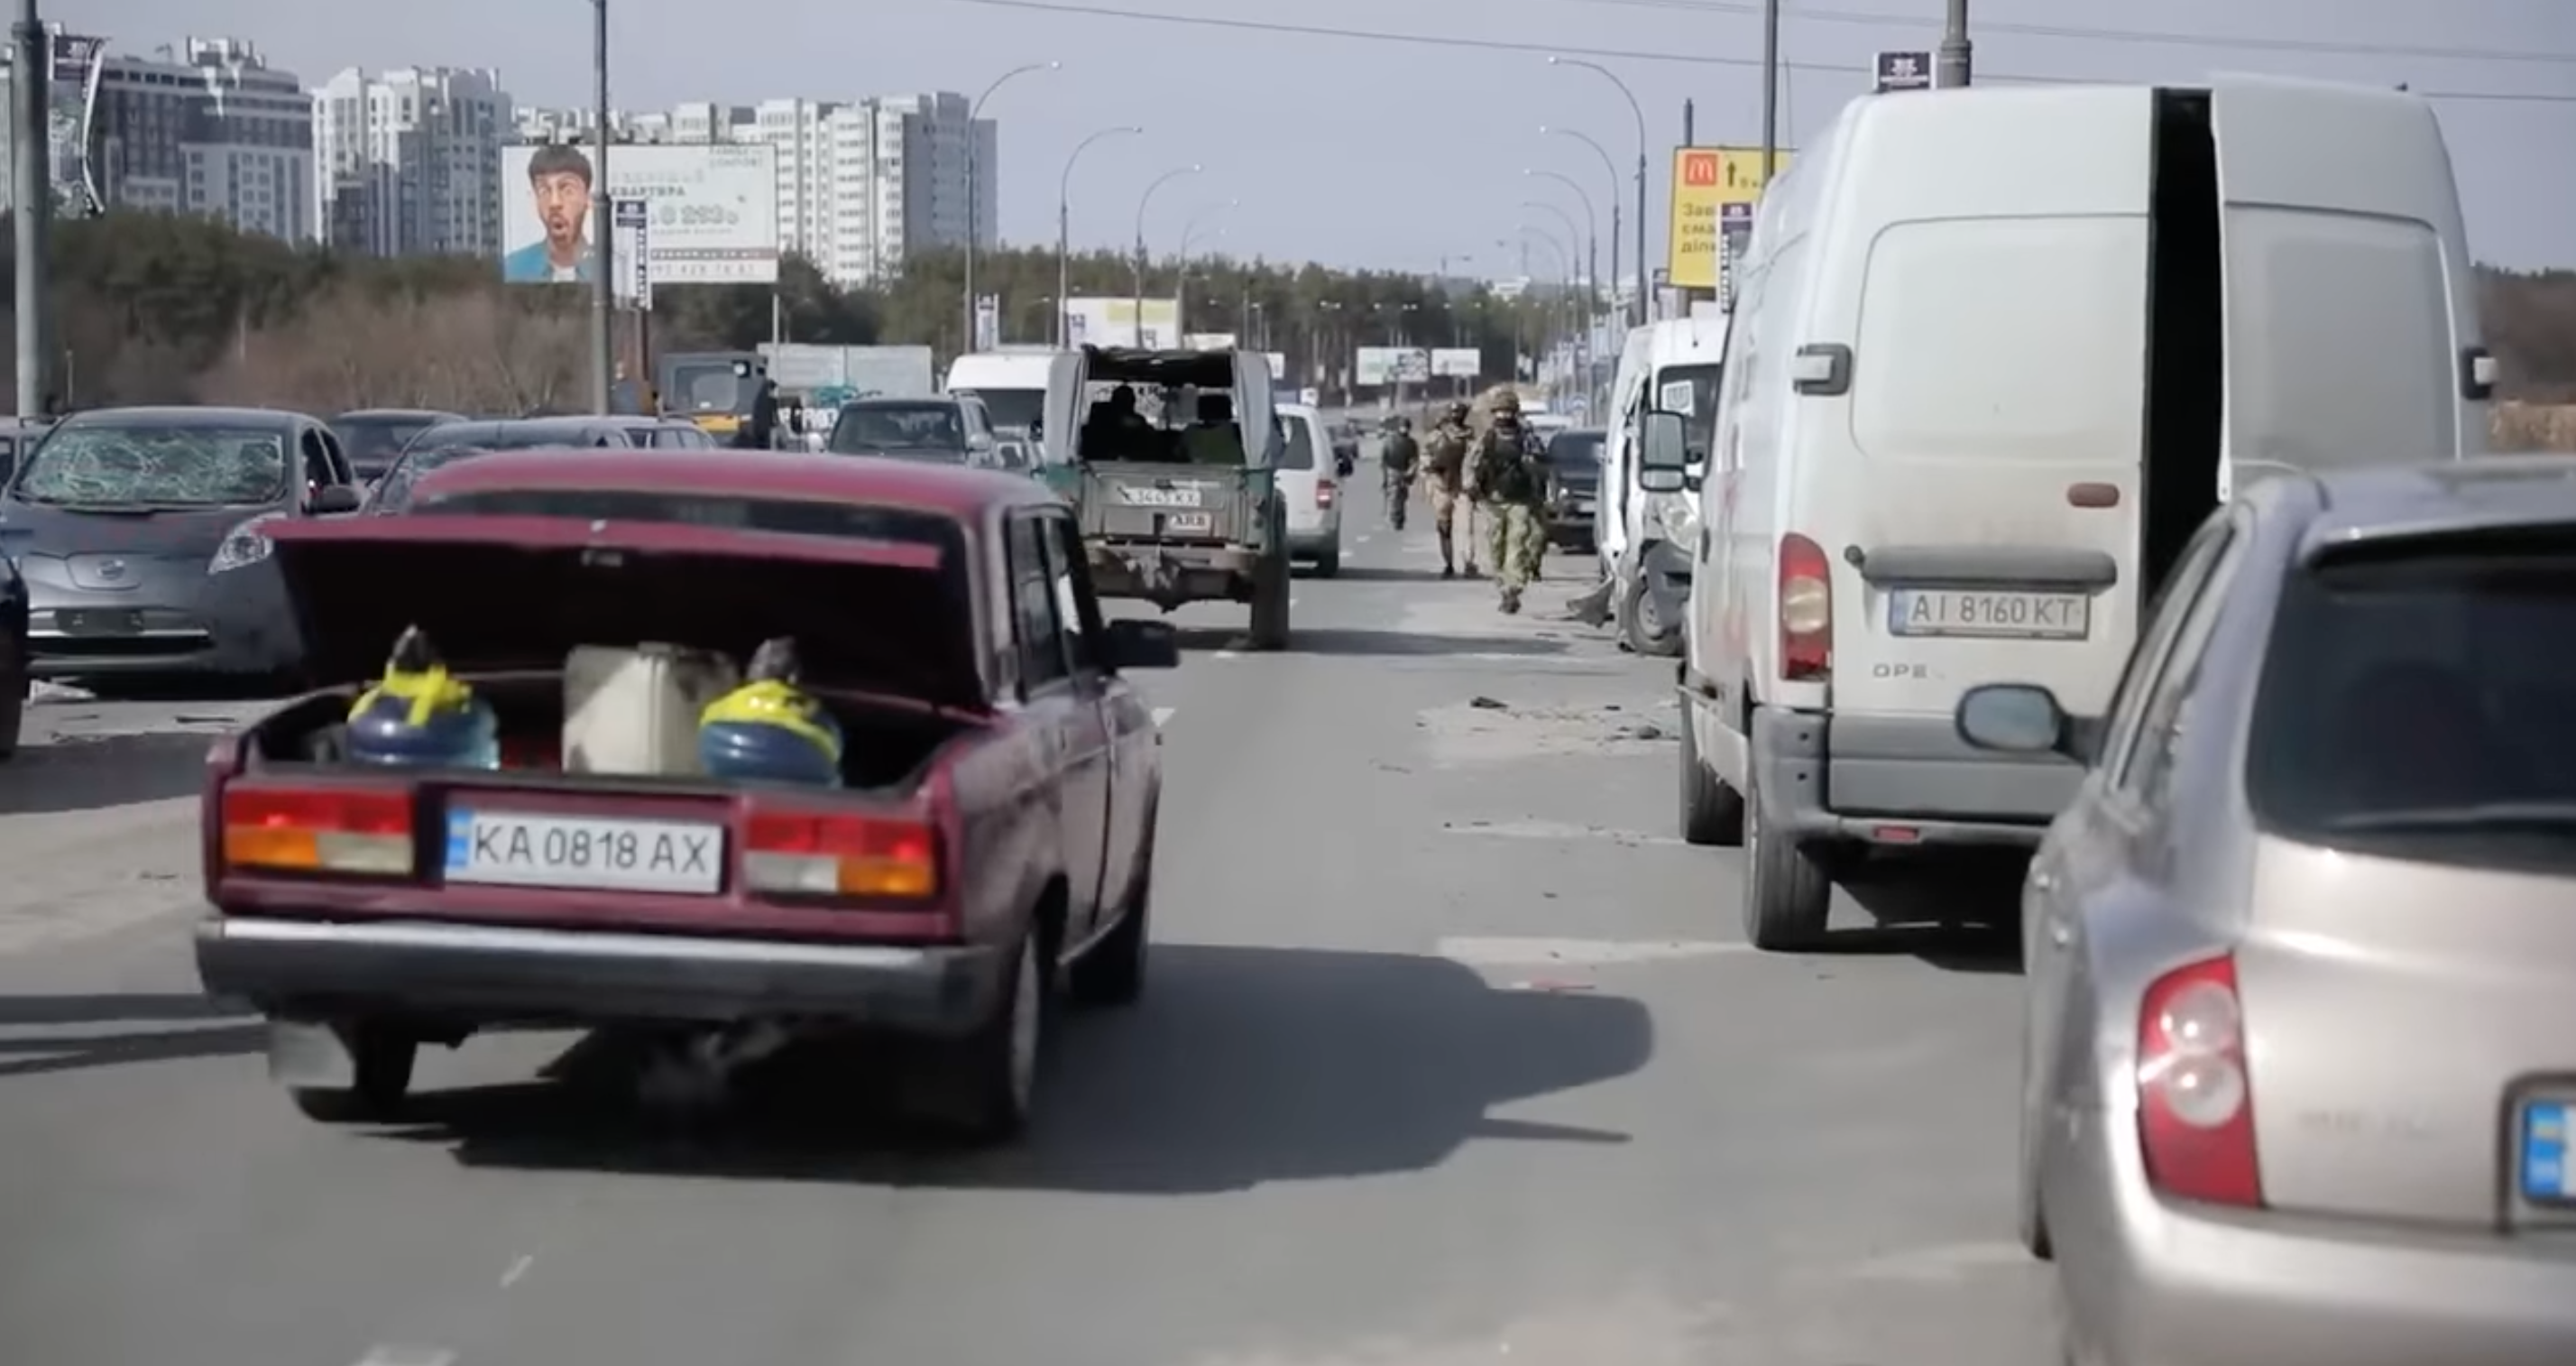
{"left": 394, "top": 946, "right": 1654, "bottom": 1194}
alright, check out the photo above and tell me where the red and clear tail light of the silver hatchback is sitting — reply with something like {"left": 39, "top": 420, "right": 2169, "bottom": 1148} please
{"left": 2138, "top": 956, "right": 2262, "bottom": 1209}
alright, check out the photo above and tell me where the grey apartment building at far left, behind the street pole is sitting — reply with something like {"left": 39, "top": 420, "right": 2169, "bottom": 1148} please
{"left": 0, "top": 39, "right": 319, "bottom": 243}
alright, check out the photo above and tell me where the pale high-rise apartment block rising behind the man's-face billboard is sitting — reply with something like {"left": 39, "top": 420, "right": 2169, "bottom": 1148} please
{"left": 518, "top": 93, "right": 1002, "bottom": 289}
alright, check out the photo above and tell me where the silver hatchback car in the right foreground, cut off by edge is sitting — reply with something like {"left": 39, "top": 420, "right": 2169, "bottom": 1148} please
{"left": 1958, "top": 457, "right": 2576, "bottom": 1366}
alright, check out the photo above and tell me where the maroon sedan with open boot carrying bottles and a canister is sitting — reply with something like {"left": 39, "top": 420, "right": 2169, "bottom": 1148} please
{"left": 196, "top": 451, "right": 1177, "bottom": 1137}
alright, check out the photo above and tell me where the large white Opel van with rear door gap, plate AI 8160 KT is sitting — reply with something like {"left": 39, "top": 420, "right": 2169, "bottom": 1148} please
{"left": 1643, "top": 80, "right": 2494, "bottom": 948}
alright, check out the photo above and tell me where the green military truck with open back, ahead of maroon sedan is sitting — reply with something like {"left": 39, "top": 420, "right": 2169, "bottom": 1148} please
{"left": 1041, "top": 346, "right": 1288, "bottom": 650}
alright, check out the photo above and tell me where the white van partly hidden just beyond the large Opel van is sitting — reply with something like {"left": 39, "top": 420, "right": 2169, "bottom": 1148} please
{"left": 1595, "top": 315, "right": 1726, "bottom": 655}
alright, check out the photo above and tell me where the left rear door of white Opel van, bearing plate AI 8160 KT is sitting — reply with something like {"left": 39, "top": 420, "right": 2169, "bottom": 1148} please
{"left": 1824, "top": 90, "right": 2154, "bottom": 725}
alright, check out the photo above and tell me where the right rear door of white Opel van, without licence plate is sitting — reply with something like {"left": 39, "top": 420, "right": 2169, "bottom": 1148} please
{"left": 2210, "top": 80, "right": 2489, "bottom": 486}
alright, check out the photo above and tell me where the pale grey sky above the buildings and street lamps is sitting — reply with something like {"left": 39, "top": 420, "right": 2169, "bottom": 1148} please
{"left": 80, "top": 0, "right": 2576, "bottom": 276}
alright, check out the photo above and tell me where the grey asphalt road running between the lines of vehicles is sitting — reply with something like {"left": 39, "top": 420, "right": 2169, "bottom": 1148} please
{"left": 0, "top": 469, "right": 2050, "bottom": 1366}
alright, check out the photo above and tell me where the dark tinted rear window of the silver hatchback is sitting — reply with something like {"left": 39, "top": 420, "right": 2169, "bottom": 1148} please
{"left": 2246, "top": 529, "right": 2576, "bottom": 863}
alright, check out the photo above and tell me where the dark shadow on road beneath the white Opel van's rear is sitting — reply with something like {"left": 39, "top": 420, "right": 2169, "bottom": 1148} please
{"left": 1824, "top": 858, "right": 2025, "bottom": 977}
